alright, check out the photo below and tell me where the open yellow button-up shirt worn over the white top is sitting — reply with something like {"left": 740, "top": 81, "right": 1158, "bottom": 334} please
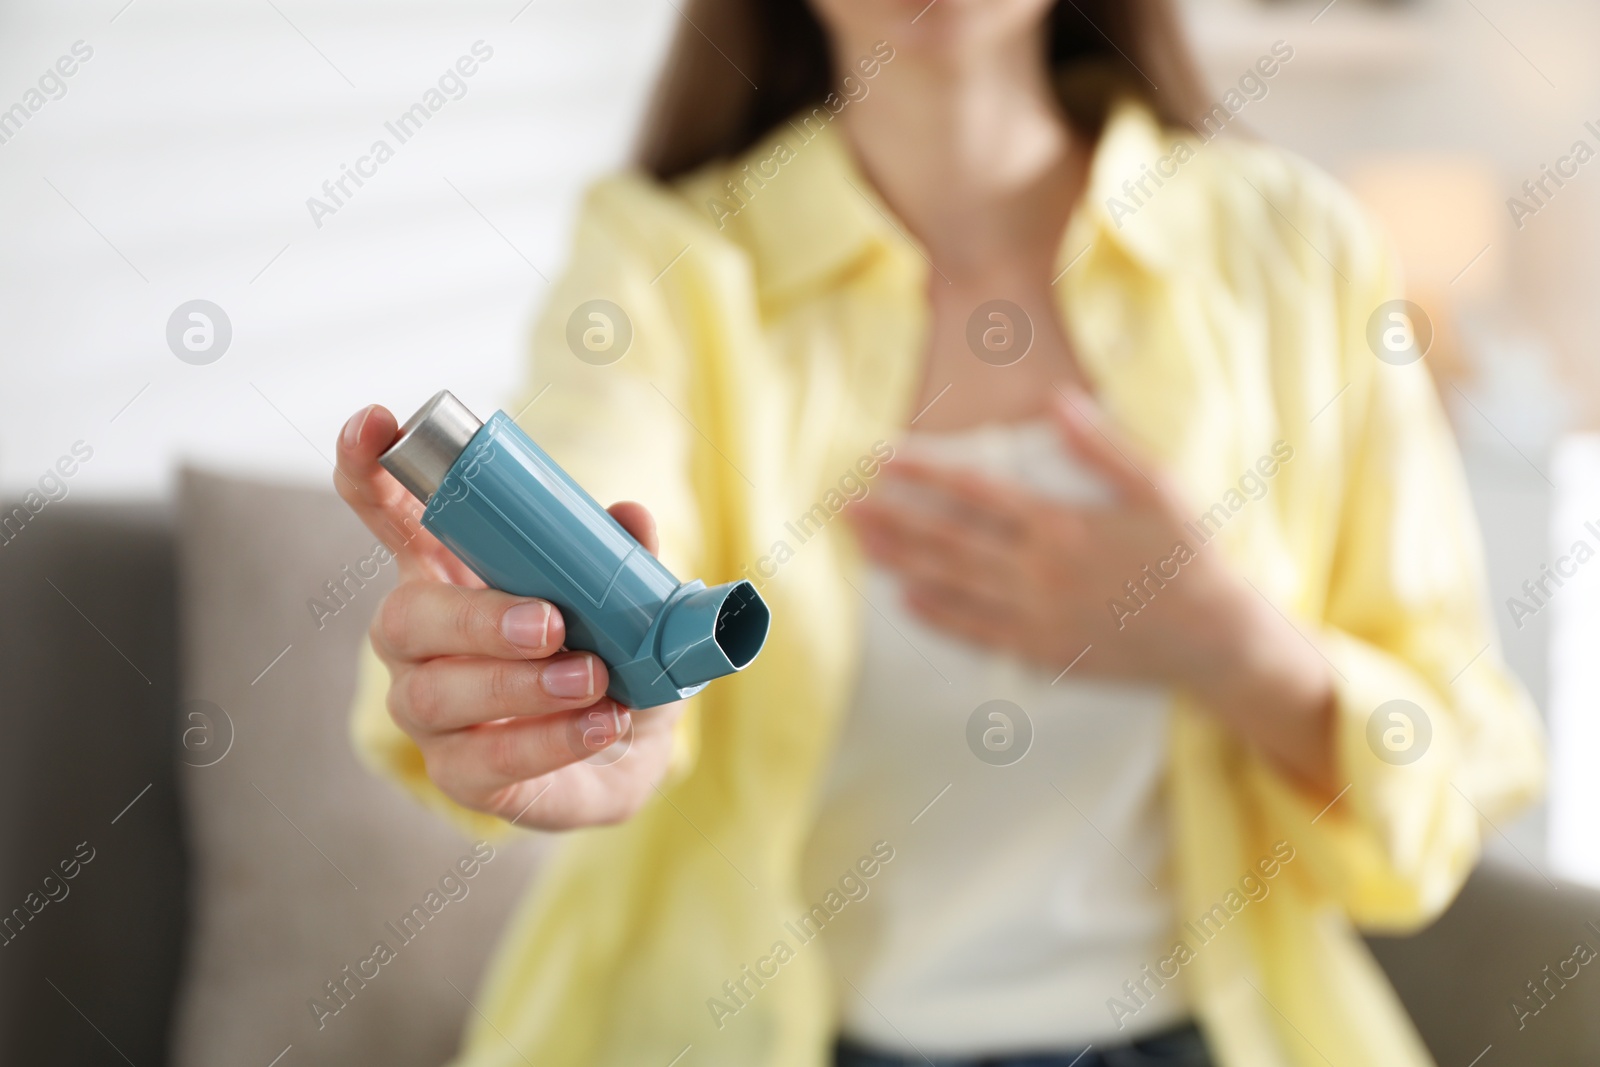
{"left": 354, "top": 102, "right": 1542, "bottom": 1067}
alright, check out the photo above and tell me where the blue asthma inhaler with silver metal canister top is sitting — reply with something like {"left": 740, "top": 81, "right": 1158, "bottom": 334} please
{"left": 378, "top": 392, "right": 771, "bottom": 707}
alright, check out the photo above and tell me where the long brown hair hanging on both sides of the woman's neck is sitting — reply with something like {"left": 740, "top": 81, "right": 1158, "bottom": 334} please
{"left": 635, "top": 0, "right": 1205, "bottom": 179}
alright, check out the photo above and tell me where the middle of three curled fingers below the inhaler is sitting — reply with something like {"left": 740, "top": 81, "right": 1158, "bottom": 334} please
{"left": 389, "top": 653, "right": 610, "bottom": 737}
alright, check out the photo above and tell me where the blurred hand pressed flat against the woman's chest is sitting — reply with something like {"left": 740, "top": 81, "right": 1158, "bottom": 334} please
{"left": 846, "top": 394, "right": 1333, "bottom": 795}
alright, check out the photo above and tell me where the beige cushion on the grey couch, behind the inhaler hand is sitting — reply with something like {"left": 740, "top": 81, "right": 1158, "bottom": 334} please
{"left": 174, "top": 470, "right": 542, "bottom": 1067}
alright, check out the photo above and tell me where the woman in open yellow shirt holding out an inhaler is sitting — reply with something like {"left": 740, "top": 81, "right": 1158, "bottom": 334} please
{"left": 339, "top": 0, "right": 1541, "bottom": 1067}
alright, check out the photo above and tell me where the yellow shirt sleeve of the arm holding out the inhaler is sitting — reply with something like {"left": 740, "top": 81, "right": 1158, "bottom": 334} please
{"left": 350, "top": 176, "right": 704, "bottom": 837}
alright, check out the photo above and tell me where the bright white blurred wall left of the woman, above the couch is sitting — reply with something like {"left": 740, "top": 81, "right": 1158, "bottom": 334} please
{"left": 0, "top": 0, "right": 678, "bottom": 498}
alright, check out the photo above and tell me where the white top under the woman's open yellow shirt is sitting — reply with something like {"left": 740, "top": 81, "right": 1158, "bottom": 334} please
{"left": 803, "top": 421, "right": 1189, "bottom": 1057}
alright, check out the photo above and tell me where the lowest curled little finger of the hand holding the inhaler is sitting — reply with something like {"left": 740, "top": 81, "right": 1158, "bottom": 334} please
{"left": 422, "top": 701, "right": 630, "bottom": 798}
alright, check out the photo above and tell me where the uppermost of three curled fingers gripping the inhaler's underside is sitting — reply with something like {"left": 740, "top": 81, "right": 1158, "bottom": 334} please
{"left": 371, "top": 579, "right": 566, "bottom": 664}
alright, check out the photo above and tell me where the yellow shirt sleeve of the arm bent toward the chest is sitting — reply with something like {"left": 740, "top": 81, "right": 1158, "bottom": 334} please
{"left": 1256, "top": 185, "right": 1544, "bottom": 933}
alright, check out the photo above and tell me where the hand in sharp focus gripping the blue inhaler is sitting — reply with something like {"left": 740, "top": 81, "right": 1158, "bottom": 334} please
{"left": 334, "top": 406, "right": 683, "bottom": 830}
